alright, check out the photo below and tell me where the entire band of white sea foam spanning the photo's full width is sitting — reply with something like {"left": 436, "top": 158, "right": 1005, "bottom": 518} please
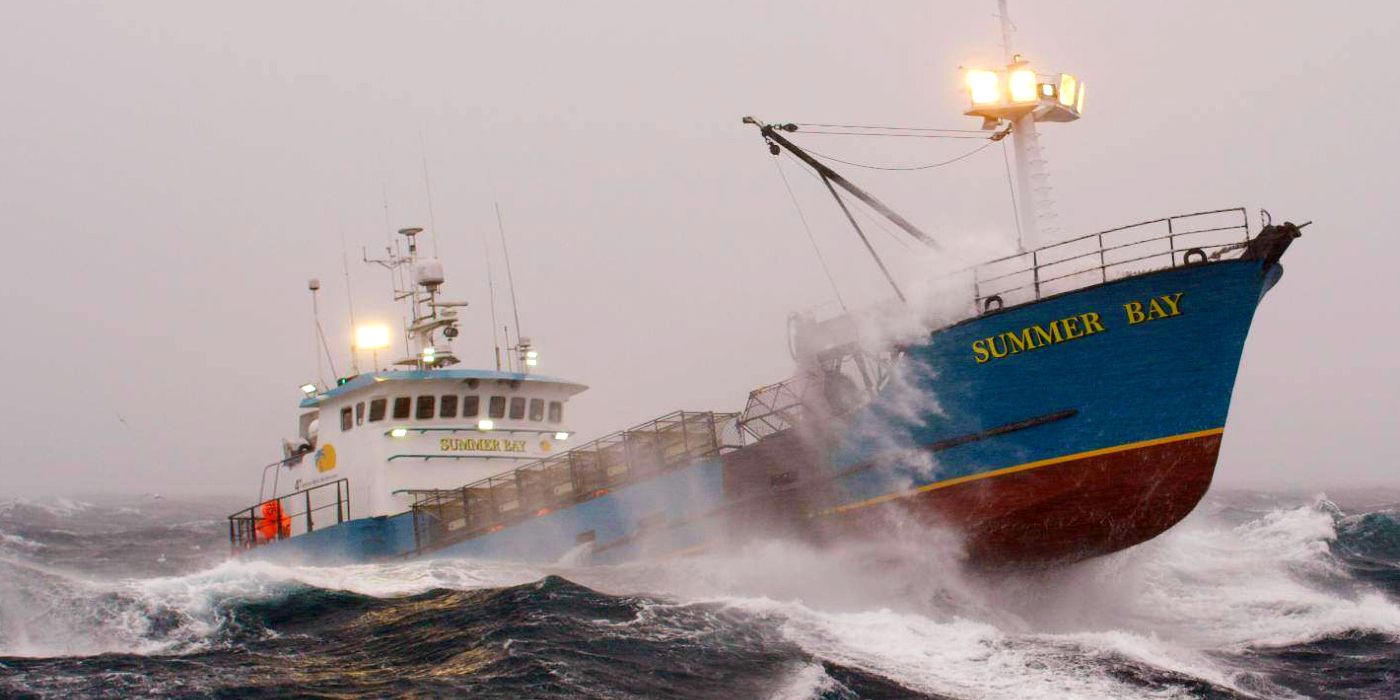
{"left": 0, "top": 498, "right": 1400, "bottom": 697}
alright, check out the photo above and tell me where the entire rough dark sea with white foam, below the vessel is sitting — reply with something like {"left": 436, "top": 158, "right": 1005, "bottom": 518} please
{"left": 0, "top": 491, "right": 1400, "bottom": 699}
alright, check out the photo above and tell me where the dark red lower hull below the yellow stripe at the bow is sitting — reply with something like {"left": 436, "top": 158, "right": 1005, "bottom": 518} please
{"left": 833, "top": 430, "right": 1221, "bottom": 567}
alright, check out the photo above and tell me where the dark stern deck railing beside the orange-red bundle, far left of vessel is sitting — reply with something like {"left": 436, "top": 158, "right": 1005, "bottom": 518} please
{"left": 228, "top": 479, "right": 350, "bottom": 552}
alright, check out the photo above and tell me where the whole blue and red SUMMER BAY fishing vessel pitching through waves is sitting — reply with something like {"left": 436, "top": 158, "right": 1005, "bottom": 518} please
{"left": 228, "top": 21, "right": 1306, "bottom": 566}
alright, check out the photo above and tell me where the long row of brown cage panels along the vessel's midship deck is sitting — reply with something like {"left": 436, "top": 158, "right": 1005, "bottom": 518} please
{"left": 403, "top": 412, "right": 738, "bottom": 553}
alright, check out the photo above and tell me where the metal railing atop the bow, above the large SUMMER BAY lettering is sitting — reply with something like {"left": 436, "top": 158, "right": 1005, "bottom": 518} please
{"left": 970, "top": 207, "right": 1250, "bottom": 312}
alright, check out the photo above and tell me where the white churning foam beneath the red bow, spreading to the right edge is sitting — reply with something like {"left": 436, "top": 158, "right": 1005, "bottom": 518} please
{"left": 577, "top": 498, "right": 1400, "bottom": 697}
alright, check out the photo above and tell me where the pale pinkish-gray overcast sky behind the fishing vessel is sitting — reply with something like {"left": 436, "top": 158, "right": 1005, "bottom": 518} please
{"left": 0, "top": 0, "right": 1400, "bottom": 496}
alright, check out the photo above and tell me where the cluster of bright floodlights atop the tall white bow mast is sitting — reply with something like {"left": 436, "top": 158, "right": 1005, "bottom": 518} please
{"left": 963, "top": 56, "right": 1084, "bottom": 123}
